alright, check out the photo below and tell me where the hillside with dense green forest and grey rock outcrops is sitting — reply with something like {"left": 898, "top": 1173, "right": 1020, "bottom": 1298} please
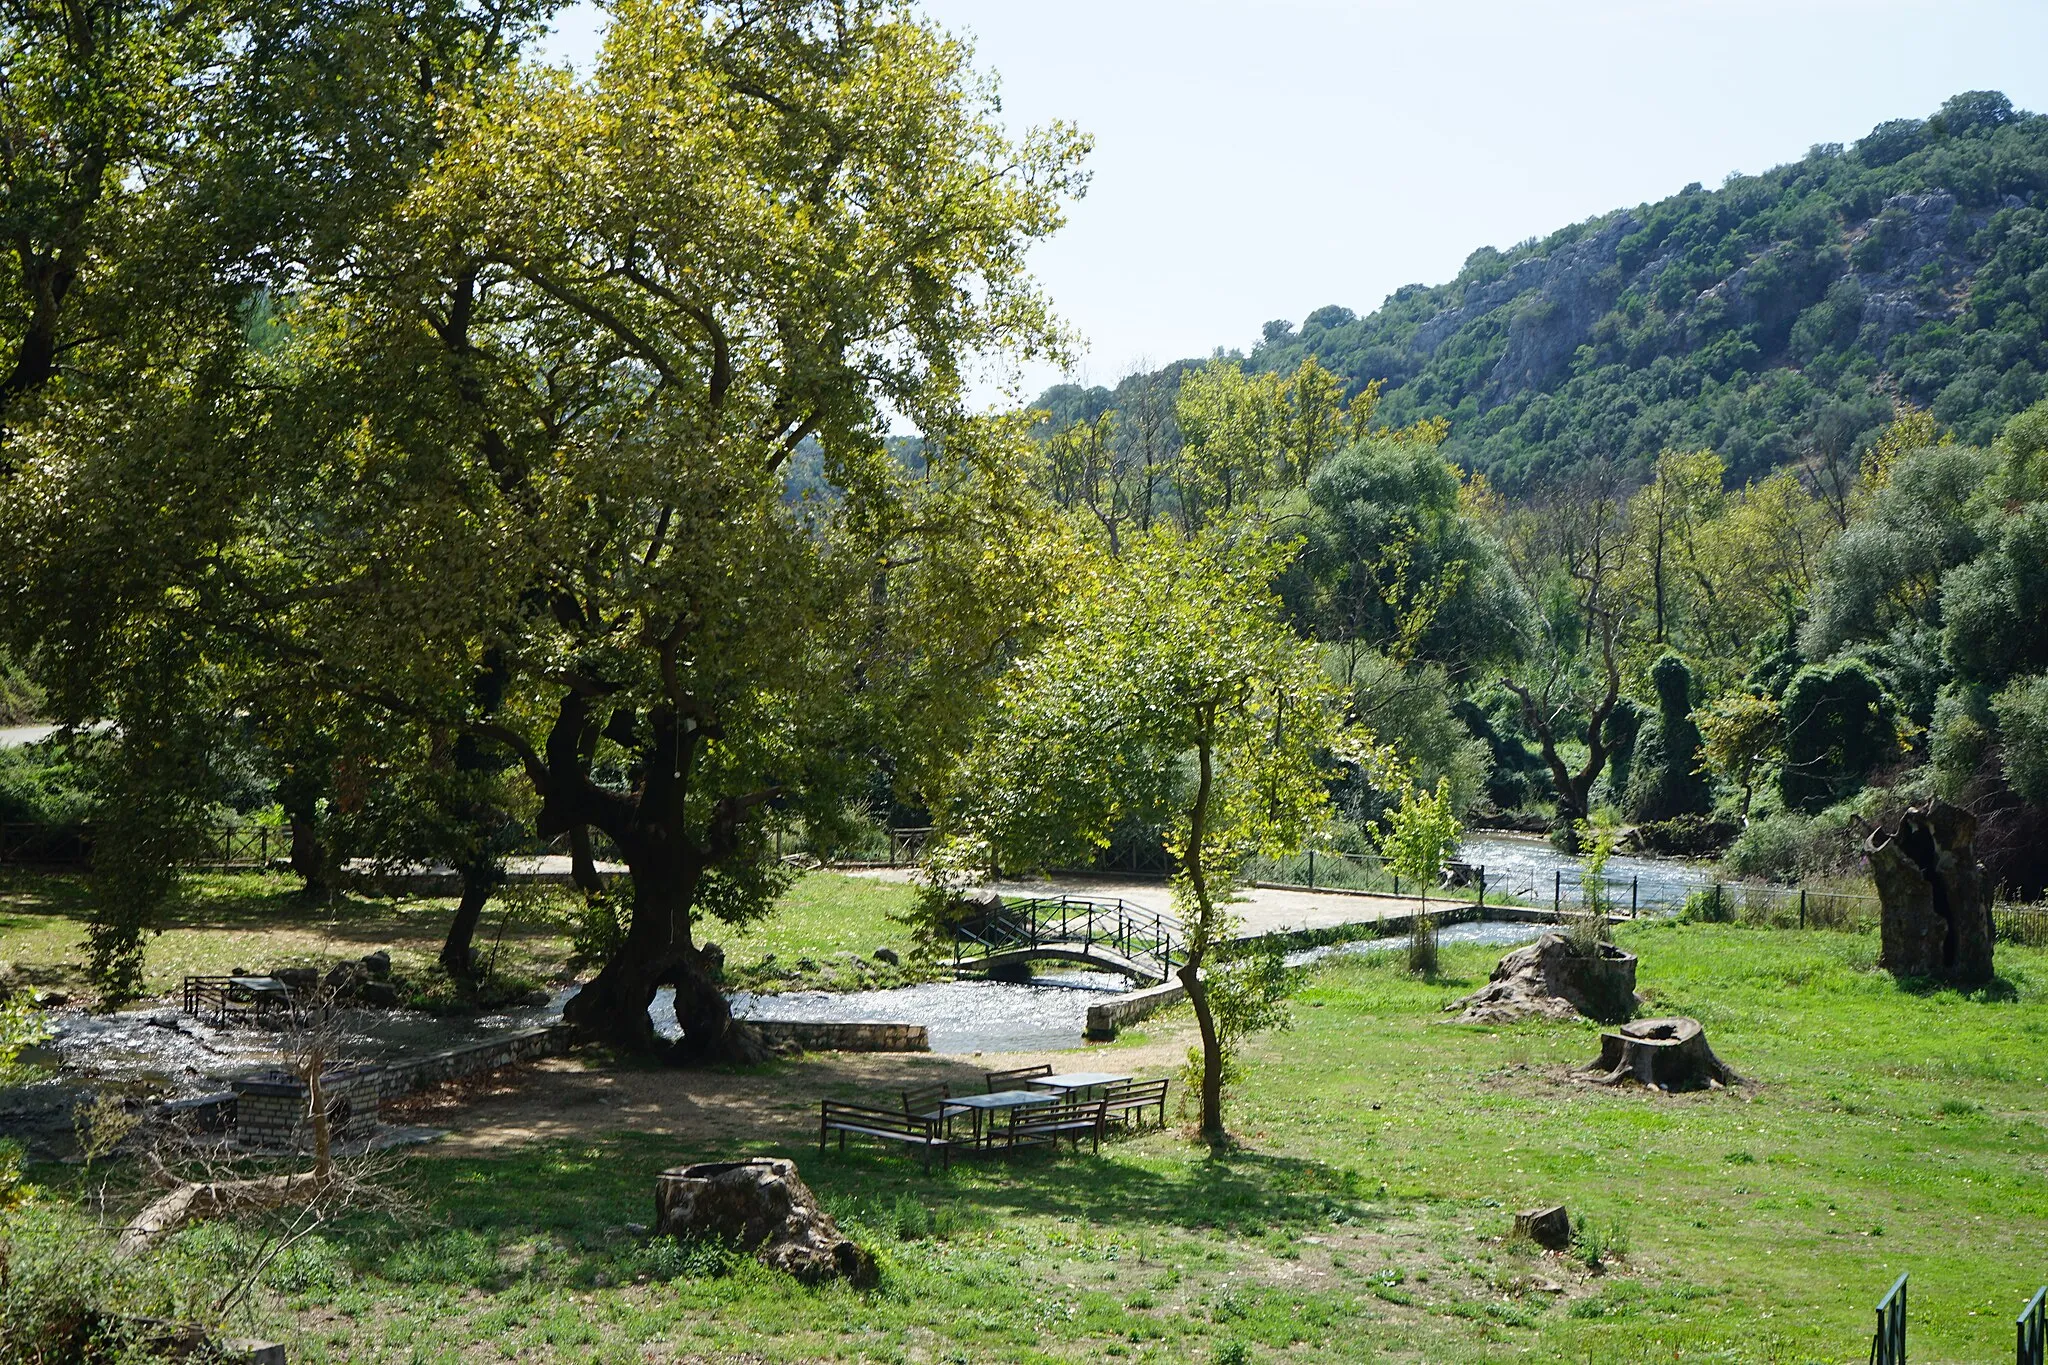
{"left": 1040, "top": 92, "right": 2048, "bottom": 493}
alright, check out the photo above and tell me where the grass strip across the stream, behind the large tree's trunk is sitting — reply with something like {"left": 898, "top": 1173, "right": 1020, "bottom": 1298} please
{"left": 0, "top": 872, "right": 911, "bottom": 995}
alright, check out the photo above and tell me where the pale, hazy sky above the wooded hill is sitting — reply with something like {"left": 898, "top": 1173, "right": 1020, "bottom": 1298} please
{"left": 549, "top": 0, "right": 2048, "bottom": 401}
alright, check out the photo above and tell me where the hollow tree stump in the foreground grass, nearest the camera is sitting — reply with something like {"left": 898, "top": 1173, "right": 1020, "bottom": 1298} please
{"left": 653, "top": 1156, "right": 874, "bottom": 1285}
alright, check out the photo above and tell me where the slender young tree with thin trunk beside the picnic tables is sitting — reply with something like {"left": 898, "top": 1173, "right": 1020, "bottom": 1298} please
{"left": 948, "top": 528, "right": 1376, "bottom": 1140}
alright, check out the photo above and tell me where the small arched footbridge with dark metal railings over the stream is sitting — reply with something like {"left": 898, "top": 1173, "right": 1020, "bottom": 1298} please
{"left": 952, "top": 896, "right": 1188, "bottom": 984}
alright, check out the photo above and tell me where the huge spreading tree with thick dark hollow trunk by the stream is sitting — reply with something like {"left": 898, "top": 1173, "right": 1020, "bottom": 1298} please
{"left": 251, "top": 4, "right": 1081, "bottom": 1058}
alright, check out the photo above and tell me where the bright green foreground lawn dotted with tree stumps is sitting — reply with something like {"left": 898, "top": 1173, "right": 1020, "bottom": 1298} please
{"left": 19, "top": 925, "right": 2048, "bottom": 1363}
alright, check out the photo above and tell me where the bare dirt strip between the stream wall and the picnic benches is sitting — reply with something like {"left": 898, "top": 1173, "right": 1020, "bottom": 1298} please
{"left": 381, "top": 1025, "right": 1194, "bottom": 1156}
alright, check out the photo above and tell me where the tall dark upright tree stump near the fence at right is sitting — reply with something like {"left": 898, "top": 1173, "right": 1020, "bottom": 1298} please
{"left": 1864, "top": 800, "right": 1991, "bottom": 986}
